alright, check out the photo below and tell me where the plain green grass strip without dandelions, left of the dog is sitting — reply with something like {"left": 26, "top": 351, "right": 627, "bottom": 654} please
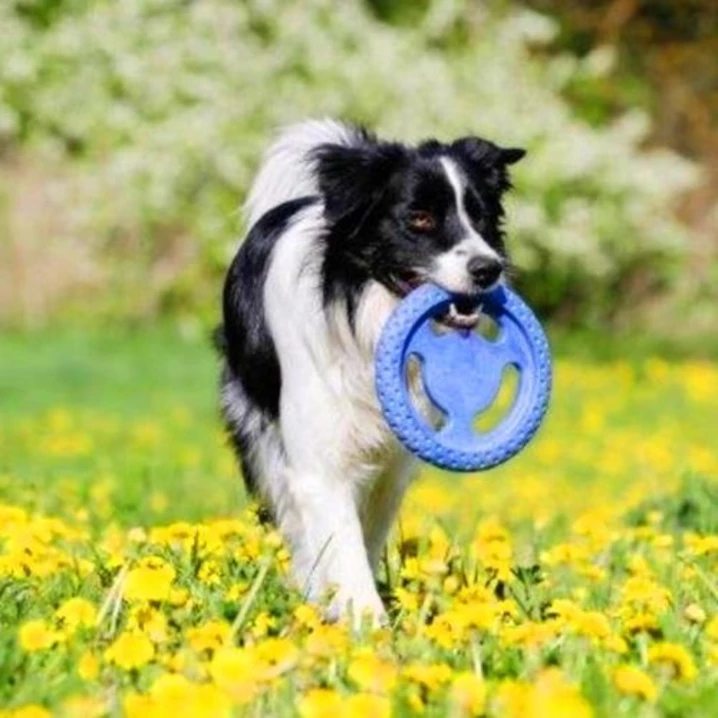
{"left": 0, "top": 326, "right": 218, "bottom": 418}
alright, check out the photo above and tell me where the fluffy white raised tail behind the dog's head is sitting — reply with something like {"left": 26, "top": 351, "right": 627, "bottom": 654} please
{"left": 244, "top": 119, "right": 366, "bottom": 227}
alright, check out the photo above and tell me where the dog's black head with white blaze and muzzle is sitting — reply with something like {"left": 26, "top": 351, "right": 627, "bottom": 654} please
{"left": 316, "top": 137, "right": 525, "bottom": 295}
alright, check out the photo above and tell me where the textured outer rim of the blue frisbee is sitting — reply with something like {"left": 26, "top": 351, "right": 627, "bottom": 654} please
{"left": 376, "top": 284, "right": 552, "bottom": 471}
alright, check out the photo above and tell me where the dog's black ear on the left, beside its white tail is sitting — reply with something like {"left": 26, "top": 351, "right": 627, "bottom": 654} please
{"left": 314, "top": 143, "right": 403, "bottom": 221}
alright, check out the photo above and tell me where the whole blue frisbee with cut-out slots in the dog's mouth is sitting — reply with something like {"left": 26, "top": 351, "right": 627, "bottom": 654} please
{"left": 376, "top": 284, "right": 551, "bottom": 471}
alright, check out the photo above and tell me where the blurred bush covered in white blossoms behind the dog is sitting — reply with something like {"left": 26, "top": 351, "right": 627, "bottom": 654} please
{"left": 0, "top": 0, "right": 695, "bottom": 324}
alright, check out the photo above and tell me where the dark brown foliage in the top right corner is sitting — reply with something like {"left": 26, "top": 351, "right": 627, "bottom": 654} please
{"left": 528, "top": 0, "right": 718, "bottom": 158}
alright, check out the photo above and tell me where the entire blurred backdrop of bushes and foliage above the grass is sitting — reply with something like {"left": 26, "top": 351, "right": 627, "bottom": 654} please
{"left": 0, "top": 0, "right": 718, "bottom": 354}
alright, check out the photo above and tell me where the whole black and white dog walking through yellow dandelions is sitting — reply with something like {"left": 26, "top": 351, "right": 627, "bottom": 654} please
{"left": 219, "top": 120, "right": 524, "bottom": 620}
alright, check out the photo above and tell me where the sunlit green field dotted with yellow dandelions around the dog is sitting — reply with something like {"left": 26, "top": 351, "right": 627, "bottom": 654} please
{"left": 0, "top": 333, "right": 718, "bottom": 718}
